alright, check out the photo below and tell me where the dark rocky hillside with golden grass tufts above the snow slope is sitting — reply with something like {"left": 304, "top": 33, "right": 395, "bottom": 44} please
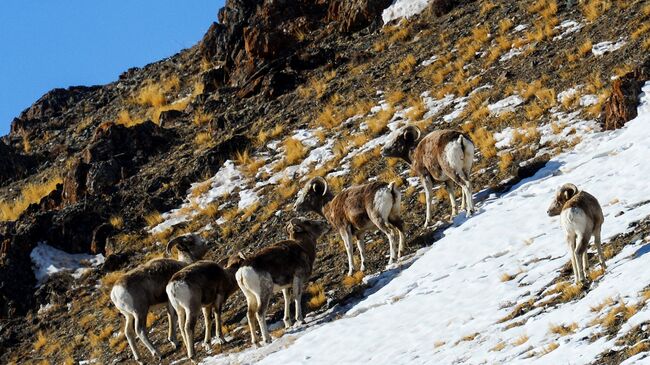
{"left": 0, "top": 0, "right": 647, "bottom": 362}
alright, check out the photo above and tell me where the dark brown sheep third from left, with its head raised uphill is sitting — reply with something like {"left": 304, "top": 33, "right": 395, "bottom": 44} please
{"left": 235, "top": 218, "right": 329, "bottom": 345}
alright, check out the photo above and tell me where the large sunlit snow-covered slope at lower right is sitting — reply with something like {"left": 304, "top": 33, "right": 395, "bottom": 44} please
{"left": 204, "top": 84, "right": 650, "bottom": 364}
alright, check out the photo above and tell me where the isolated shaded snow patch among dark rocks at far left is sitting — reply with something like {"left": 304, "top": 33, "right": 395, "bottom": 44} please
{"left": 29, "top": 242, "right": 104, "bottom": 286}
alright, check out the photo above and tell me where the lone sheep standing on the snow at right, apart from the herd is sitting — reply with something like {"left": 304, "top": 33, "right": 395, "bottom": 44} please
{"left": 547, "top": 184, "right": 607, "bottom": 284}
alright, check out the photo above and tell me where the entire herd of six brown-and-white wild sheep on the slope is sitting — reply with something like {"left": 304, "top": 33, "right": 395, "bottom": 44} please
{"left": 111, "top": 126, "right": 605, "bottom": 361}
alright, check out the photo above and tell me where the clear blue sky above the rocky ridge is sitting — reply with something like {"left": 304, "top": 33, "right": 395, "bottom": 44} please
{"left": 0, "top": 0, "right": 224, "bottom": 135}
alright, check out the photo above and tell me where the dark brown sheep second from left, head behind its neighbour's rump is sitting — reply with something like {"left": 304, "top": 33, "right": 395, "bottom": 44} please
{"left": 166, "top": 256, "right": 241, "bottom": 359}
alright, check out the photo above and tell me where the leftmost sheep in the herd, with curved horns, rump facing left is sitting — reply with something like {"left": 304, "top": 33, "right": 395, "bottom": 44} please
{"left": 111, "top": 235, "right": 208, "bottom": 362}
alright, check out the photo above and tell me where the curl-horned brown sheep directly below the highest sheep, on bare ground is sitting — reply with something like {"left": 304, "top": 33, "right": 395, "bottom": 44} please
{"left": 294, "top": 177, "right": 404, "bottom": 275}
